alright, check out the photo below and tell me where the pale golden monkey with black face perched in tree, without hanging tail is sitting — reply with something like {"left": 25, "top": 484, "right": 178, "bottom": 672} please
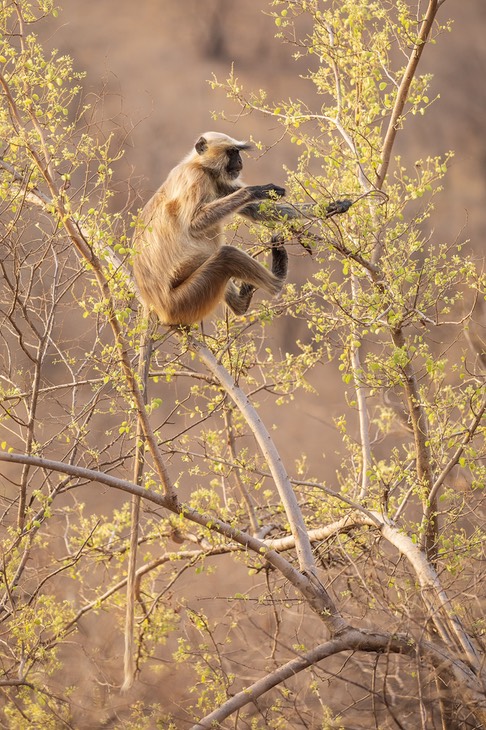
{"left": 134, "top": 132, "right": 287, "bottom": 325}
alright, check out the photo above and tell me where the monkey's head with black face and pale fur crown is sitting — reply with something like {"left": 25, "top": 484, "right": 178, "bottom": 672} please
{"left": 194, "top": 132, "right": 252, "bottom": 180}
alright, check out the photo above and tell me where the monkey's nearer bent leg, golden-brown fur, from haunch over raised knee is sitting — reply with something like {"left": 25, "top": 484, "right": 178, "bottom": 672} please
{"left": 164, "top": 246, "right": 285, "bottom": 324}
